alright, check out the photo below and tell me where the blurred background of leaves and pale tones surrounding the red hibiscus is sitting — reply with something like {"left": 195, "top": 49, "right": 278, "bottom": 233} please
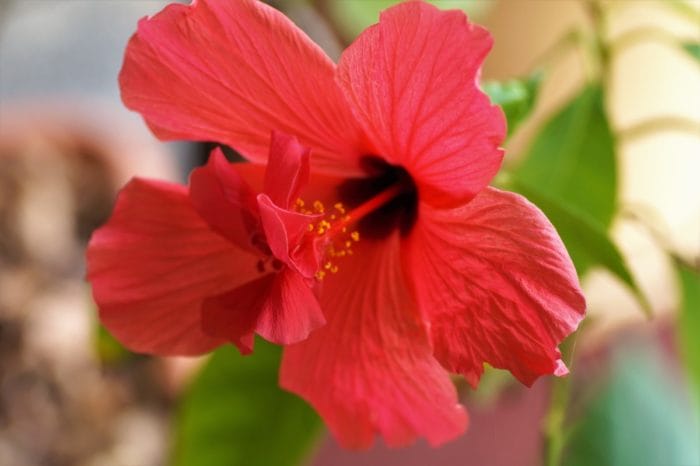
{"left": 0, "top": 0, "right": 700, "bottom": 466}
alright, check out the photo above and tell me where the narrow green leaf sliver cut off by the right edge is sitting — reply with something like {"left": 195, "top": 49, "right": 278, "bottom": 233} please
{"left": 676, "top": 262, "right": 700, "bottom": 403}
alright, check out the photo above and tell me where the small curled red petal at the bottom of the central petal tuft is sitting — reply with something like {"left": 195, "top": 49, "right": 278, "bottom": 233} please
{"left": 203, "top": 267, "right": 325, "bottom": 354}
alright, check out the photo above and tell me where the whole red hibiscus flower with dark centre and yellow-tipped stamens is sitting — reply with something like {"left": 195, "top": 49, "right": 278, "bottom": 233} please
{"left": 88, "top": 0, "right": 585, "bottom": 447}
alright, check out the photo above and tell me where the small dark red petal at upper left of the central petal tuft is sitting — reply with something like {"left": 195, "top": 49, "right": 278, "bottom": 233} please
{"left": 190, "top": 148, "right": 260, "bottom": 253}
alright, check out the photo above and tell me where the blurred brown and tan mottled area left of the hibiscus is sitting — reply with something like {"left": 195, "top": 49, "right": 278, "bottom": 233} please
{"left": 0, "top": 105, "right": 174, "bottom": 466}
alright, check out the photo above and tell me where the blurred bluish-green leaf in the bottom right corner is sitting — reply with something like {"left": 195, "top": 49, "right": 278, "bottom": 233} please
{"left": 562, "top": 344, "right": 700, "bottom": 466}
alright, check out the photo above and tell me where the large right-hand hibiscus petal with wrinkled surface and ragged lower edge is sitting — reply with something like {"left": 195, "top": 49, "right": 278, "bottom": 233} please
{"left": 405, "top": 188, "right": 586, "bottom": 386}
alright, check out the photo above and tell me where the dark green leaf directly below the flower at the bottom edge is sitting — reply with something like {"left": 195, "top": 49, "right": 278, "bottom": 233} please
{"left": 173, "top": 339, "right": 322, "bottom": 466}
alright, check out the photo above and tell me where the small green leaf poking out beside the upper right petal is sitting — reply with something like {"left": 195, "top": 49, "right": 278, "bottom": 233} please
{"left": 483, "top": 73, "right": 542, "bottom": 136}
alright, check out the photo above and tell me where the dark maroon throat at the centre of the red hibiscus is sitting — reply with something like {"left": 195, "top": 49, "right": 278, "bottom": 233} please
{"left": 338, "top": 155, "right": 418, "bottom": 239}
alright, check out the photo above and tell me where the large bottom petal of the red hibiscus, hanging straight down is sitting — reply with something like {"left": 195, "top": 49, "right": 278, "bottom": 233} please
{"left": 280, "top": 234, "right": 467, "bottom": 448}
